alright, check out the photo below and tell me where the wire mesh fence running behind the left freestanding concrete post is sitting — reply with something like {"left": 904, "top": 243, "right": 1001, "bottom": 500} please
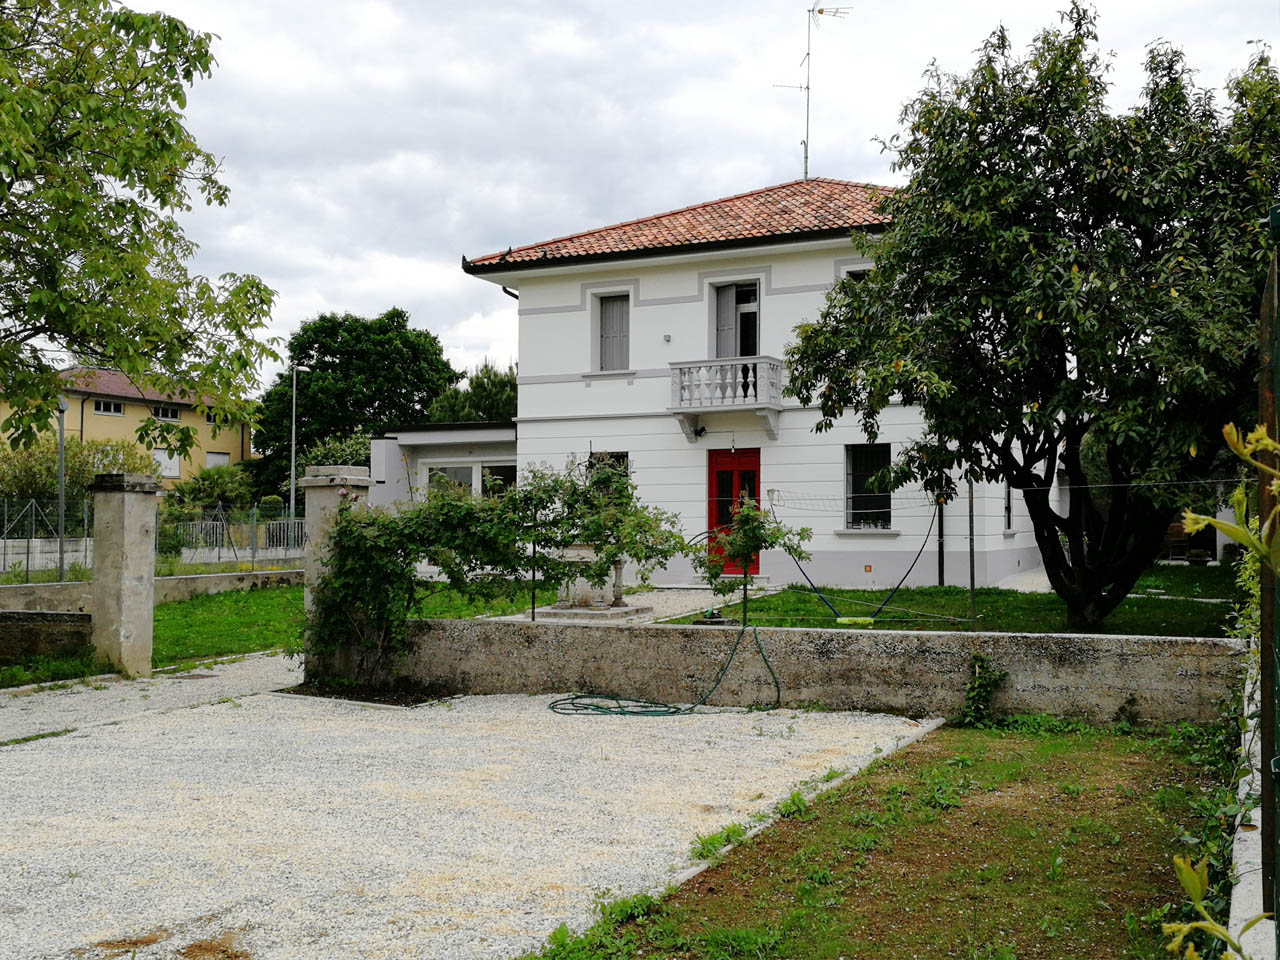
{"left": 0, "top": 498, "right": 306, "bottom": 585}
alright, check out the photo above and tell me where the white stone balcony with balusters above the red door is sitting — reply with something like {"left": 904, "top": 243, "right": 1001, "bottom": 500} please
{"left": 667, "top": 357, "right": 782, "bottom": 443}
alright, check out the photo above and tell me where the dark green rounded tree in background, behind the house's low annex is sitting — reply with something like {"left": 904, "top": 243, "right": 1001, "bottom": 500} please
{"left": 252, "top": 307, "right": 462, "bottom": 493}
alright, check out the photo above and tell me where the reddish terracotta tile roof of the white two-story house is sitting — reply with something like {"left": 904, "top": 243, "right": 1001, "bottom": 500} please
{"left": 462, "top": 177, "right": 891, "bottom": 273}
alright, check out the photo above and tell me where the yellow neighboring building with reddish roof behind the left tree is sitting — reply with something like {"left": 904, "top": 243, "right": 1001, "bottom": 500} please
{"left": 0, "top": 366, "right": 252, "bottom": 486}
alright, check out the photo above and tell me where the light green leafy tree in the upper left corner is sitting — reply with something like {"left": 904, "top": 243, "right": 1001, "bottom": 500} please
{"left": 0, "top": 0, "right": 274, "bottom": 452}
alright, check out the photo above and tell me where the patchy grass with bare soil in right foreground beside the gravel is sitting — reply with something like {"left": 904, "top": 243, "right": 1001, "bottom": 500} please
{"left": 530, "top": 723, "right": 1213, "bottom": 960}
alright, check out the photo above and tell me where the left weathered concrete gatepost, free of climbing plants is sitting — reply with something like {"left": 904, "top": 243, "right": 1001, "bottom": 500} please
{"left": 90, "top": 474, "right": 160, "bottom": 677}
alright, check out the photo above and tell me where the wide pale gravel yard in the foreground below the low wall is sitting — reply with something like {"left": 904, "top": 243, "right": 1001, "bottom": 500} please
{"left": 0, "top": 686, "right": 932, "bottom": 960}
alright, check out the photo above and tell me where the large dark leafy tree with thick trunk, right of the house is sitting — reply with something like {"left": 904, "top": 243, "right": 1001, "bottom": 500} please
{"left": 788, "top": 6, "right": 1280, "bottom": 626}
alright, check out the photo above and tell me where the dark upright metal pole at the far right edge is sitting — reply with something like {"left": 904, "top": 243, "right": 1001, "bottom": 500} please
{"left": 1258, "top": 244, "right": 1280, "bottom": 921}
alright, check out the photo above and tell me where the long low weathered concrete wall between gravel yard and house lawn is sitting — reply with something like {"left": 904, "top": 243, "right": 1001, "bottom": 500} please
{"left": 376, "top": 620, "right": 1243, "bottom": 722}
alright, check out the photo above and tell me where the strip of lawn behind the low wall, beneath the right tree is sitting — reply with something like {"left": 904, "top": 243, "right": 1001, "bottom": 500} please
{"left": 666, "top": 586, "right": 1230, "bottom": 637}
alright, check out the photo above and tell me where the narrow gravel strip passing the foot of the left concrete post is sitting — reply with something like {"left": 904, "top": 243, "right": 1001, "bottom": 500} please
{"left": 0, "top": 655, "right": 302, "bottom": 742}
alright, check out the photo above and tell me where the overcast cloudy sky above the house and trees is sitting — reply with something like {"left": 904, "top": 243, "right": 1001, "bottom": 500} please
{"left": 154, "top": 0, "right": 1280, "bottom": 391}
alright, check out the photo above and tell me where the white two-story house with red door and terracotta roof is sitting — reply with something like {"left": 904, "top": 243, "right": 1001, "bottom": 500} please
{"left": 372, "top": 179, "right": 1039, "bottom": 586}
